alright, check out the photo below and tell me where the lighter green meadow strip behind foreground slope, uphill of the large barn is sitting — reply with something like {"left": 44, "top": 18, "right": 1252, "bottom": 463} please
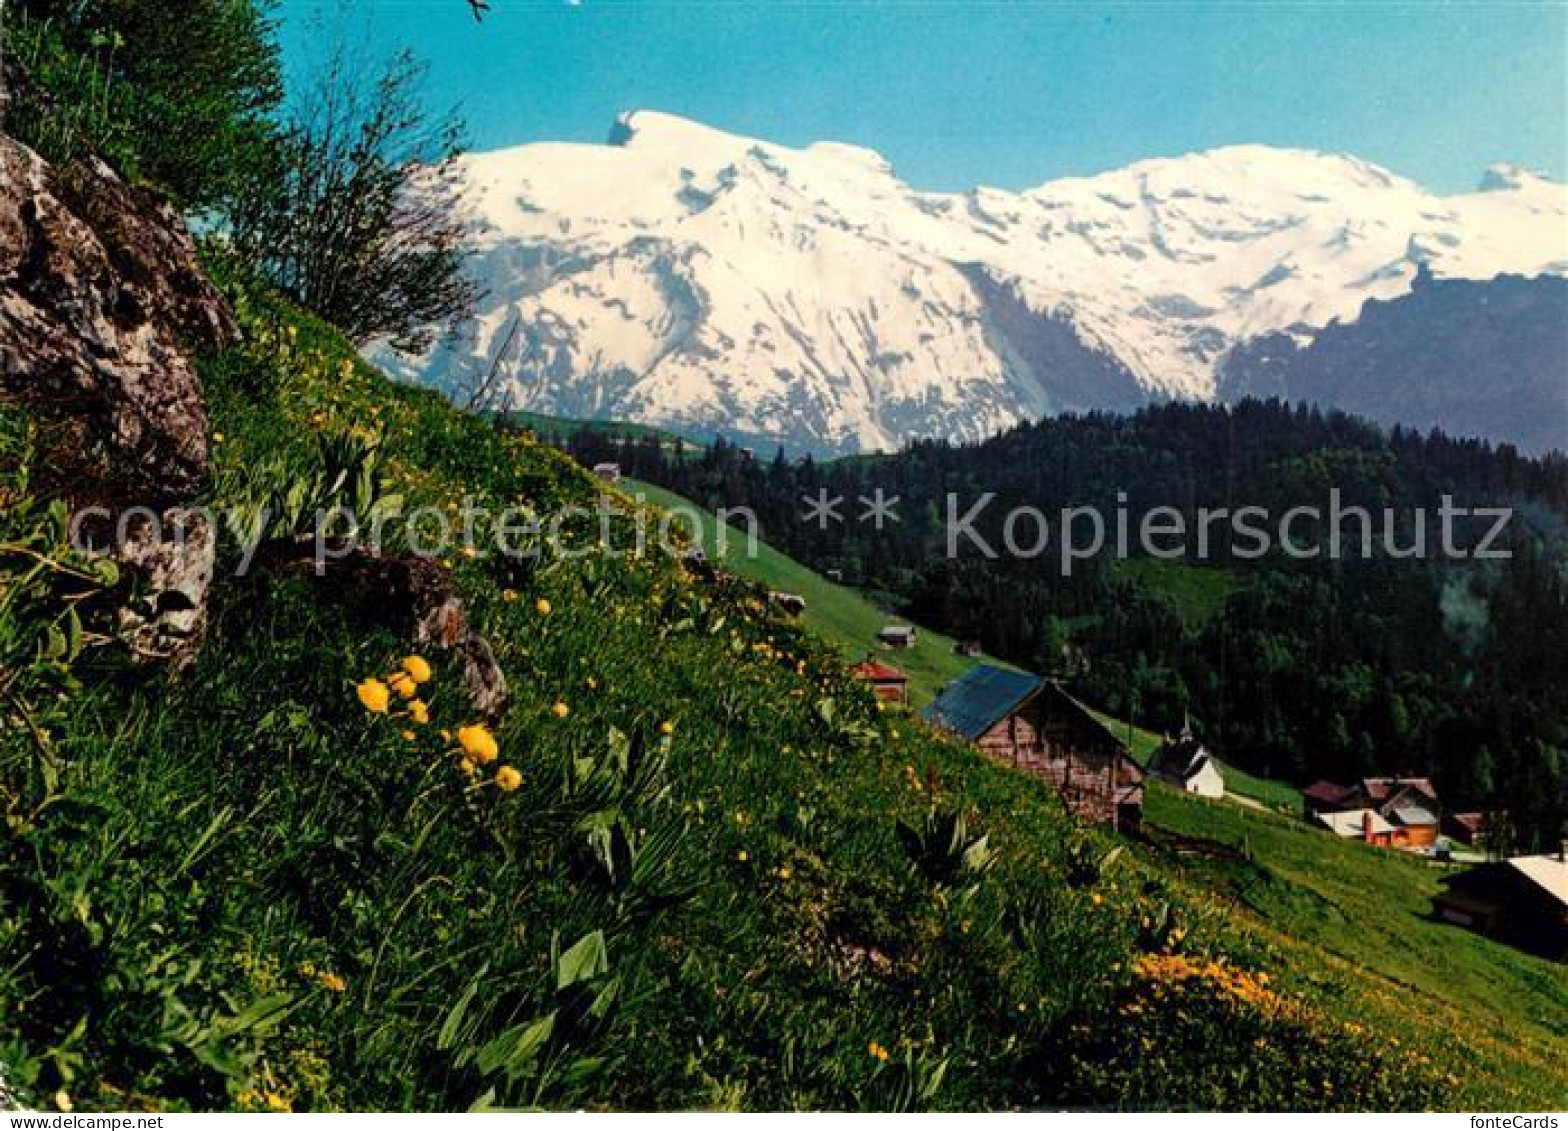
{"left": 622, "top": 480, "right": 1008, "bottom": 706}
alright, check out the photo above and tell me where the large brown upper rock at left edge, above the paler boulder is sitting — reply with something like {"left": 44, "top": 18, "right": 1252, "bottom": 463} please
{"left": 0, "top": 136, "right": 237, "bottom": 502}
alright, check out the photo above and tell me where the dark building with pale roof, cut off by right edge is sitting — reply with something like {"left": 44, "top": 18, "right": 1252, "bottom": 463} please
{"left": 1432, "top": 846, "right": 1568, "bottom": 962}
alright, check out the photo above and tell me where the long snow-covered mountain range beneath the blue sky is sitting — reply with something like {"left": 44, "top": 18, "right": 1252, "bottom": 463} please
{"left": 375, "top": 111, "right": 1568, "bottom": 450}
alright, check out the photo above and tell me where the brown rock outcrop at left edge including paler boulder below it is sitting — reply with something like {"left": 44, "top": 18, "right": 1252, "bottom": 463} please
{"left": 0, "top": 124, "right": 238, "bottom": 664}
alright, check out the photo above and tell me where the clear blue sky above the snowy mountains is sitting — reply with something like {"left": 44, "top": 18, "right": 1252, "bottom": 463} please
{"left": 278, "top": 0, "right": 1568, "bottom": 191}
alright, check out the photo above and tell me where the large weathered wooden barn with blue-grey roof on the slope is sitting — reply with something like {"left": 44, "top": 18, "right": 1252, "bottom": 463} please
{"left": 925, "top": 664, "right": 1143, "bottom": 828}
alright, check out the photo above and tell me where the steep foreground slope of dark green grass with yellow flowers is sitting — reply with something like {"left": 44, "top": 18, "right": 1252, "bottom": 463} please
{"left": 0, "top": 279, "right": 1565, "bottom": 1109}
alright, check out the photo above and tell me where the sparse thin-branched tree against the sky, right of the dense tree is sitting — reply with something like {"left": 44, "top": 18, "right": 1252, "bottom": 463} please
{"left": 230, "top": 52, "right": 478, "bottom": 350}
